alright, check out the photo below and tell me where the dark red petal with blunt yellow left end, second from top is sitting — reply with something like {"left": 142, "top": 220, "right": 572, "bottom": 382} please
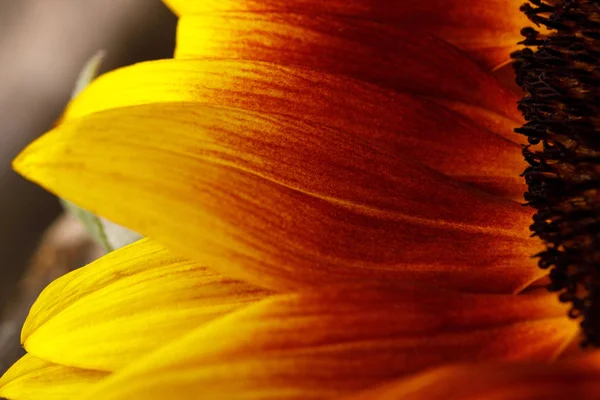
{"left": 175, "top": 13, "right": 522, "bottom": 140}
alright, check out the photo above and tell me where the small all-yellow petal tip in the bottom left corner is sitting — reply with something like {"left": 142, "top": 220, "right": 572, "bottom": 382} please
{"left": 0, "top": 354, "right": 109, "bottom": 400}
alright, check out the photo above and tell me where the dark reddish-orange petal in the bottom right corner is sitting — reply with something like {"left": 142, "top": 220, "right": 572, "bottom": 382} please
{"left": 348, "top": 351, "right": 600, "bottom": 400}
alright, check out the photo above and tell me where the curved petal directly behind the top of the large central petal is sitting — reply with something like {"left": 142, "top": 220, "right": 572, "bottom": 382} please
{"left": 64, "top": 60, "right": 526, "bottom": 201}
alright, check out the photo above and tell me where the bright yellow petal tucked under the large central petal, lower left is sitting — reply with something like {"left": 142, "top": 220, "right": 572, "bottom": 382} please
{"left": 22, "top": 239, "right": 268, "bottom": 371}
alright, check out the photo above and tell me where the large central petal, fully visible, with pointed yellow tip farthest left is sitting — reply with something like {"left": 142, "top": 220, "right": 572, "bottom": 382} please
{"left": 15, "top": 104, "right": 540, "bottom": 292}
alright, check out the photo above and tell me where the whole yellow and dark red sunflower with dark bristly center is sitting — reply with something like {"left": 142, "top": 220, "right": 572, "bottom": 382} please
{"left": 0, "top": 0, "right": 600, "bottom": 400}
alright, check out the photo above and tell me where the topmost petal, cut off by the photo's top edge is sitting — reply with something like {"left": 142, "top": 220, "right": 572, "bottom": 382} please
{"left": 164, "top": 0, "right": 531, "bottom": 67}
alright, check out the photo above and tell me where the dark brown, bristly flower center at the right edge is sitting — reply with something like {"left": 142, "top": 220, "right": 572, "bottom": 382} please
{"left": 512, "top": 0, "right": 600, "bottom": 347}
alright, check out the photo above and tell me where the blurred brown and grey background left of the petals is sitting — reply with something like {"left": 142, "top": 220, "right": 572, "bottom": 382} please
{"left": 0, "top": 0, "right": 176, "bottom": 374}
